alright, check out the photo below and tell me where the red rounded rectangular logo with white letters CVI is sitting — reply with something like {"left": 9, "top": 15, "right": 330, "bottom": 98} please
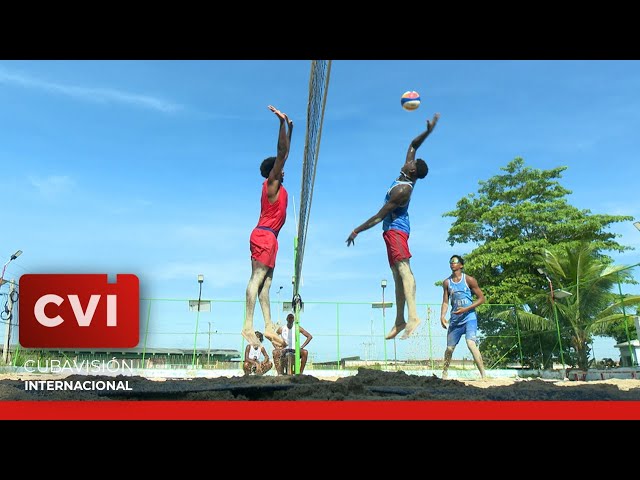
{"left": 18, "top": 274, "right": 140, "bottom": 348}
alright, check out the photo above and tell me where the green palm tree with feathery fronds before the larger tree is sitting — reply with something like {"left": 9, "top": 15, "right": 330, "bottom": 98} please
{"left": 496, "top": 242, "right": 640, "bottom": 370}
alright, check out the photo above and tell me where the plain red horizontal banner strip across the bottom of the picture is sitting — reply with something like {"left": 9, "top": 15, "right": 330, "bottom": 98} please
{"left": 0, "top": 401, "right": 640, "bottom": 420}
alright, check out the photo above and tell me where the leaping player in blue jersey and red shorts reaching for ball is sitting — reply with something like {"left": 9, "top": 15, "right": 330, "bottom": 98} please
{"left": 347, "top": 113, "right": 440, "bottom": 340}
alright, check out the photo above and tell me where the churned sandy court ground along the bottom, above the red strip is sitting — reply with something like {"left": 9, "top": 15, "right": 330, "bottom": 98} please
{"left": 0, "top": 369, "right": 640, "bottom": 401}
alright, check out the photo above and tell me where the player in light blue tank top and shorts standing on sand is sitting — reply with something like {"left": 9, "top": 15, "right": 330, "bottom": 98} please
{"left": 440, "top": 255, "right": 485, "bottom": 379}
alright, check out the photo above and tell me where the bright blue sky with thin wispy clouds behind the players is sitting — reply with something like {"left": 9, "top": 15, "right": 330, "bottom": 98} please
{"left": 0, "top": 60, "right": 640, "bottom": 360}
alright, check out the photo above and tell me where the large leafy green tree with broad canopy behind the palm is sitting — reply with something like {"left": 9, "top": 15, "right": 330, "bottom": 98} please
{"left": 443, "top": 158, "right": 633, "bottom": 366}
